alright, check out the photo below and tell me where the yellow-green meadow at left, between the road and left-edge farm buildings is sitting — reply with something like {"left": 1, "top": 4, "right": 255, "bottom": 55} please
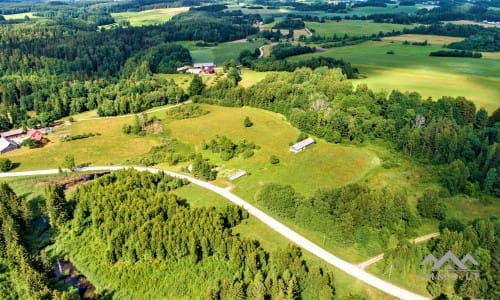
{"left": 2, "top": 117, "right": 157, "bottom": 171}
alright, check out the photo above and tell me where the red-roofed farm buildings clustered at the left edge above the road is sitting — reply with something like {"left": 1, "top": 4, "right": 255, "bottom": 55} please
{"left": 0, "top": 127, "right": 52, "bottom": 153}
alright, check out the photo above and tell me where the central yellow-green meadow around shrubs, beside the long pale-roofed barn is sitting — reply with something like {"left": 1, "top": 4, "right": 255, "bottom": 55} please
{"left": 168, "top": 105, "right": 378, "bottom": 199}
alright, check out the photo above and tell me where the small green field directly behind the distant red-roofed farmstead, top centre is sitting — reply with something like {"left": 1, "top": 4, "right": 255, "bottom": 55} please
{"left": 190, "top": 40, "right": 264, "bottom": 65}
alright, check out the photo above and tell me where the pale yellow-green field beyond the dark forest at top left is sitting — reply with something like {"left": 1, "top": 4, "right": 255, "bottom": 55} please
{"left": 111, "top": 7, "right": 189, "bottom": 26}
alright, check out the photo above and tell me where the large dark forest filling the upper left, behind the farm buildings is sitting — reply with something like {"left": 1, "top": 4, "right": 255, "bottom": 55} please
{"left": 0, "top": 8, "right": 258, "bottom": 130}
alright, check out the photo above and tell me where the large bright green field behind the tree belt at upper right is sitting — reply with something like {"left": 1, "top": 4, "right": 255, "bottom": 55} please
{"left": 290, "top": 40, "right": 500, "bottom": 113}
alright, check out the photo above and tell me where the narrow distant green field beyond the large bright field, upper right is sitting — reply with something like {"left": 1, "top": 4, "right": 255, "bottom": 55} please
{"left": 306, "top": 20, "right": 414, "bottom": 37}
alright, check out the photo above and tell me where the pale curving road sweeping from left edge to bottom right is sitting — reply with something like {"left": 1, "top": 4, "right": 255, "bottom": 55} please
{"left": 0, "top": 166, "right": 429, "bottom": 300}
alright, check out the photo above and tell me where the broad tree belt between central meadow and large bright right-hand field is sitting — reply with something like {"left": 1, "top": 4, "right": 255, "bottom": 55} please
{"left": 197, "top": 68, "right": 500, "bottom": 196}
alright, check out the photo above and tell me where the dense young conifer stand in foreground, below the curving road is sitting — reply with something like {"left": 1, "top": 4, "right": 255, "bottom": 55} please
{"left": 61, "top": 171, "right": 335, "bottom": 299}
